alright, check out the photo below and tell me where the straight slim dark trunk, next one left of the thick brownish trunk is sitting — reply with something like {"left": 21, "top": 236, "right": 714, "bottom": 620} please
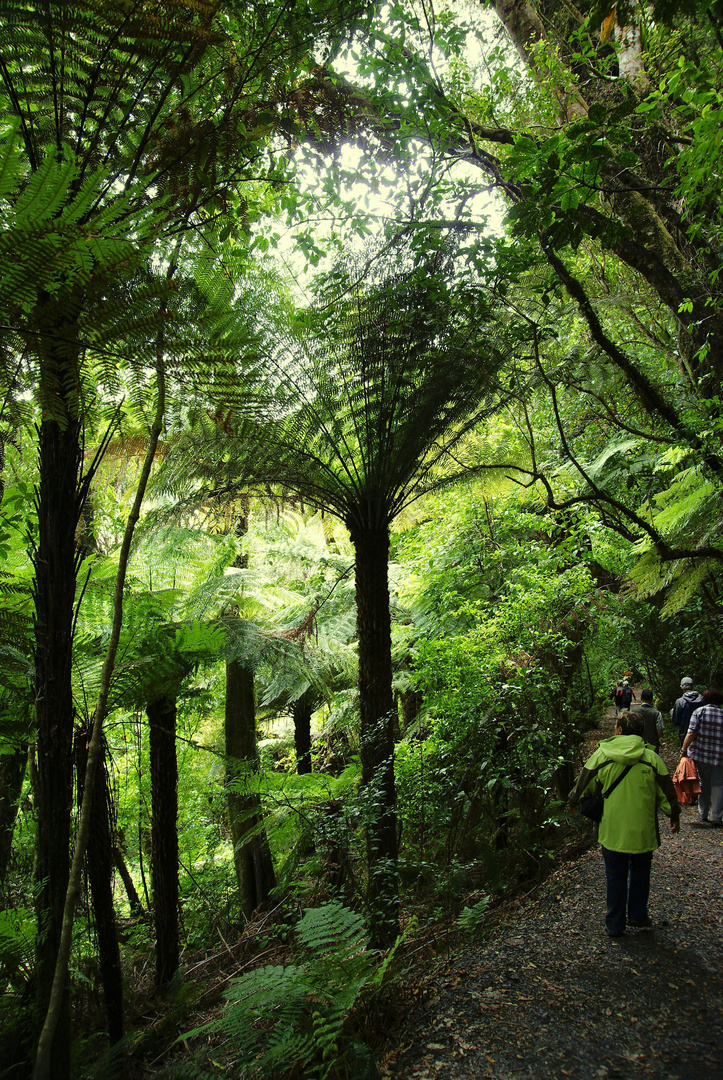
{"left": 146, "top": 697, "right": 179, "bottom": 989}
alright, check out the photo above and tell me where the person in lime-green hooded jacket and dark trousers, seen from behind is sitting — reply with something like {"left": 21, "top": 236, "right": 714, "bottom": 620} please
{"left": 568, "top": 712, "right": 680, "bottom": 937}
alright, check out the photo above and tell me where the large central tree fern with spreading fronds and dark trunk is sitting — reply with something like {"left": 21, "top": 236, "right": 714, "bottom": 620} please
{"left": 161, "top": 237, "right": 523, "bottom": 945}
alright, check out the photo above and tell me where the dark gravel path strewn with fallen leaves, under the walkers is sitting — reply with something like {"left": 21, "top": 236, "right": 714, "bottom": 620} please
{"left": 383, "top": 721, "right": 723, "bottom": 1080}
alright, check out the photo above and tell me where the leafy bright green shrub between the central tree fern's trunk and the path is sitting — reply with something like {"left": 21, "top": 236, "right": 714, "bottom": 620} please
{"left": 397, "top": 496, "right": 597, "bottom": 891}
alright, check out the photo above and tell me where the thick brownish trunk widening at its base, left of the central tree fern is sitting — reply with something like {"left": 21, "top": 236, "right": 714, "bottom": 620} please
{"left": 225, "top": 660, "right": 276, "bottom": 918}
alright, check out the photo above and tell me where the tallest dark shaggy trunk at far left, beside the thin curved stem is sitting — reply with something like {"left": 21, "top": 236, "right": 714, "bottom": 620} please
{"left": 34, "top": 319, "right": 82, "bottom": 1080}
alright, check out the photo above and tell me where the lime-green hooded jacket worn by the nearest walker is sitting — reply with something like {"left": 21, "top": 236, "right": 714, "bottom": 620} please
{"left": 568, "top": 735, "right": 680, "bottom": 854}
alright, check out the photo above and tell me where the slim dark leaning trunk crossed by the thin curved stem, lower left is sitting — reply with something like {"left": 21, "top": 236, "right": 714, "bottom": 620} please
{"left": 76, "top": 731, "right": 123, "bottom": 1043}
